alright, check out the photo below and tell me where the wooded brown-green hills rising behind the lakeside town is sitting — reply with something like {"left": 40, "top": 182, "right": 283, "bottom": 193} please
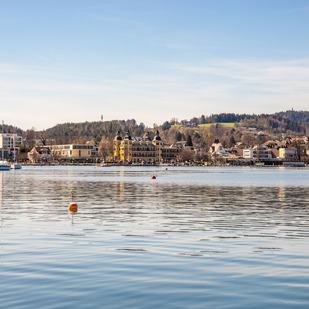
{"left": 4, "top": 111, "right": 309, "bottom": 152}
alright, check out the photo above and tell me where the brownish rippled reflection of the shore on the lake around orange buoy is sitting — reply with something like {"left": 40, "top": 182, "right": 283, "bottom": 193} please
{"left": 0, "top": 167, "right": 309, "bottom": 237}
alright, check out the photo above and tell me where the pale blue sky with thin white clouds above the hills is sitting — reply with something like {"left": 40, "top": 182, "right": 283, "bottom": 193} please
{"left": 0, "top": 0, "right": 309, "bottom": 130}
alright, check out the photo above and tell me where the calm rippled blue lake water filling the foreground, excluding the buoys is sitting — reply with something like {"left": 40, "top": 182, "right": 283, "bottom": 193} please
{"left": 0, "top": 167, "right": 309, "bottom": 309}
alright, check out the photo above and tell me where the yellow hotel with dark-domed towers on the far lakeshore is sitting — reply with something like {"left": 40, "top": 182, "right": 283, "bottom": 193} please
{"left": 114, "top": 131, "right": 182, "bottom": 164}
